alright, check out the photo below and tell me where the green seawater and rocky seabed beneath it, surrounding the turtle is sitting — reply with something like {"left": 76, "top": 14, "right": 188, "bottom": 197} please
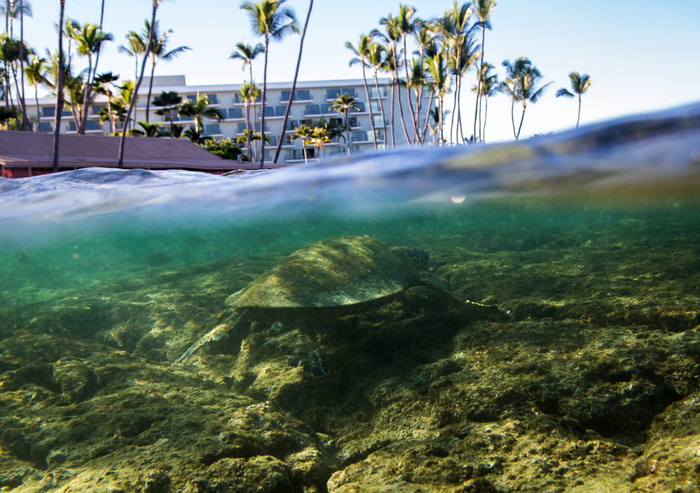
{"left": 0, "top": 108, "right": 700, "bottom": 492}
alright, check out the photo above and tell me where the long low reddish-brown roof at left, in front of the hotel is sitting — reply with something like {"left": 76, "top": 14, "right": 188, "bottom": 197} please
{"left": 0, "top": 130, "right": 268, "bottom": 174}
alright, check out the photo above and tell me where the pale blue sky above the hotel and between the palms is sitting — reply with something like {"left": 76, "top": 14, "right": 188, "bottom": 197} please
{"left": 19, "top": 0, "right": 700, "bottom": 142}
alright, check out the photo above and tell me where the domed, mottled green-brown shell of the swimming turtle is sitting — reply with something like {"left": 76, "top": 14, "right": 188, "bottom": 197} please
{"left": 226, "top": 236, "right": 412, "bottom": 308}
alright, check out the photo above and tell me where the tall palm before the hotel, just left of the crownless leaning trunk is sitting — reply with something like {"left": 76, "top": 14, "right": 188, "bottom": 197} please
{"left": 241, "top": 0, "right": 299, "bottom": 168}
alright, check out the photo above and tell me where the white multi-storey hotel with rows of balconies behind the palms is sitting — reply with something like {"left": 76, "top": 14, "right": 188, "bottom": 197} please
{"left": 27, "top": 75, "right": 430, "bottom": 164}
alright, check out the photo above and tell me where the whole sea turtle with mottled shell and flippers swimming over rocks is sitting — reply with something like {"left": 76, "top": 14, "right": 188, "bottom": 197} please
{"left": 174, "top": 235, "right": 500, "bottom": 396}
